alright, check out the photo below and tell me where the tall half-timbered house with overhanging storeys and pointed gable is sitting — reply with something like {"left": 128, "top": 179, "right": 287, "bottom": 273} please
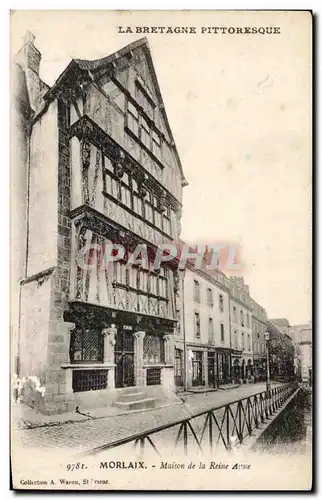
{"left": 17, "top": 37, "right": 186, "bottom": 413}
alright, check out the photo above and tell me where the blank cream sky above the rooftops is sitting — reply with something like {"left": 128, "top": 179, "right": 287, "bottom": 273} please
{"left": 11, "top": 11, "right": 312, "bottom": 324}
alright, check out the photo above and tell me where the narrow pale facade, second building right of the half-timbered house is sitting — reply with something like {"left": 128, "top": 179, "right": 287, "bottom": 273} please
{"left": 230, "top": 277, "right": 253, "bottom": 381}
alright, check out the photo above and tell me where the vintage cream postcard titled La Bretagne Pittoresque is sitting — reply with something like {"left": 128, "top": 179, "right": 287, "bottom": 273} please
{"left": 10, "top": 10, "right": 313, "bottom": 491}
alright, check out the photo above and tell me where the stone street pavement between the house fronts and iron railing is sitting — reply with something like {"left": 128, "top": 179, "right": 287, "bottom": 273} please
{"left": 12, "top": 383, "right": 280, "bottom": 453}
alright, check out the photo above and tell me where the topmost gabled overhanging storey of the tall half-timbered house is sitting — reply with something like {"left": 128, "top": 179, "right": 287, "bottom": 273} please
{"left": 45, "top": 38, "right": 187, "bottom": 208}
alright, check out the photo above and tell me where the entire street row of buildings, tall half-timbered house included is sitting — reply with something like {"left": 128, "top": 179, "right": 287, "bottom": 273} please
{"left": 11, "top": 33, "right": 312, "bottom": 413}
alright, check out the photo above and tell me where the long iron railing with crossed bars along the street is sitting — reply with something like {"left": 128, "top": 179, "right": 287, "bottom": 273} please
{"left": 84, "top": 382, "right": 298, "bottom": 456}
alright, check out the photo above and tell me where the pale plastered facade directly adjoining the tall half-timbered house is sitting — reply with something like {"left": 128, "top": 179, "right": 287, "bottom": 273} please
{"left": 175, "top": 264, "right": 231, "bottom": 388}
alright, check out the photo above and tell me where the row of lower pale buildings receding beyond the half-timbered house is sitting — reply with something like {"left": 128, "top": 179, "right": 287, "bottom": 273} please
{"left": 174, "top": 266, "right": 309, "bottom": 388}
